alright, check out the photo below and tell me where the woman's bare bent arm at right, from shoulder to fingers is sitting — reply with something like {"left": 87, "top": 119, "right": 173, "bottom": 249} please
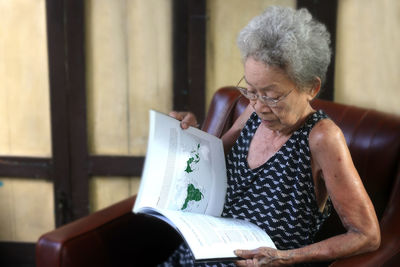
{"left": 237, "top": 120, "right": 380, "bottom": 266}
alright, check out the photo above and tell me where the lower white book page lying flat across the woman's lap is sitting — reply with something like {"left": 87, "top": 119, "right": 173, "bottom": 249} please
{"left": 161, "top": 210, "right": 276, "bottom": 260}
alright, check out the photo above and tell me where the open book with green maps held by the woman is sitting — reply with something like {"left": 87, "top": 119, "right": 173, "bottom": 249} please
{"left": 133, "top": 110, "right": 275, "bottom": 261}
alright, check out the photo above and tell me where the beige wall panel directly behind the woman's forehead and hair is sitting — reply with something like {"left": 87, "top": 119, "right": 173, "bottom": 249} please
{"left": 206, "top": 0, "right": 296, "bottom": 109}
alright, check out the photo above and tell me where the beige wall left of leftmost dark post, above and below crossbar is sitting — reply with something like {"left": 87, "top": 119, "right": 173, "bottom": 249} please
{"left": 0, "top": 0, "right": 54, "bottom": 242}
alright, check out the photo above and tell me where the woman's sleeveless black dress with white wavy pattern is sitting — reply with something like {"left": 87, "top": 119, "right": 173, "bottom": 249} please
{"left": 161, "top": 110, "right": 332, "bottom": 266}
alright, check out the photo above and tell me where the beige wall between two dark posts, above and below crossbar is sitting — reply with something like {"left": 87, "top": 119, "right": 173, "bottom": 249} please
{"left": 86, "top": 0, "right": 172, "bottom": 213}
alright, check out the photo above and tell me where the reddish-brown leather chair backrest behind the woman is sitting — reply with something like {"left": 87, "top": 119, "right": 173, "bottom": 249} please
{"left": 203, "top": 87, "right": 400, "bottom": 245}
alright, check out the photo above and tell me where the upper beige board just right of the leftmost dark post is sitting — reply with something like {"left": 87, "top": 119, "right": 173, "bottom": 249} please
{"left": 85, "top": 0, "right": 129, "bottom": 155}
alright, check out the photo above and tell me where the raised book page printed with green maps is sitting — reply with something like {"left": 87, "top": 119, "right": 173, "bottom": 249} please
{"left": 134, "top": 111, "right": 227, "bottom": 216}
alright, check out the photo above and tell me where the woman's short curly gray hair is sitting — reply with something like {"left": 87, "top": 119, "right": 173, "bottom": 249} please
{"left": 237, "top": 6, "right": 331, "bottom": 88}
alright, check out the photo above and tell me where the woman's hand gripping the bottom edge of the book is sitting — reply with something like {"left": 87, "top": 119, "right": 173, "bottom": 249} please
{"left": 235, "top": 247, "right": 285, "bottom": 267}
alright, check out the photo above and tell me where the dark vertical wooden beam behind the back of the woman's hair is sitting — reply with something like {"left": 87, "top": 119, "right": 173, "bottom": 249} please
{"left": 297, "top": 0, "right": 338, "bottom": 101}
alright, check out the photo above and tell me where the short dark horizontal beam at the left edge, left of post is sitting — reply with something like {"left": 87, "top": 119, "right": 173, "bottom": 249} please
{"left": 0, "top": 157, "right": 53, "bottom": 179}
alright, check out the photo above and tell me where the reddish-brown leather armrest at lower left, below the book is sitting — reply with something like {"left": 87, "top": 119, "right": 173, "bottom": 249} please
{"left": 36, "top": 197, "right": 181, "bottom": 267}
